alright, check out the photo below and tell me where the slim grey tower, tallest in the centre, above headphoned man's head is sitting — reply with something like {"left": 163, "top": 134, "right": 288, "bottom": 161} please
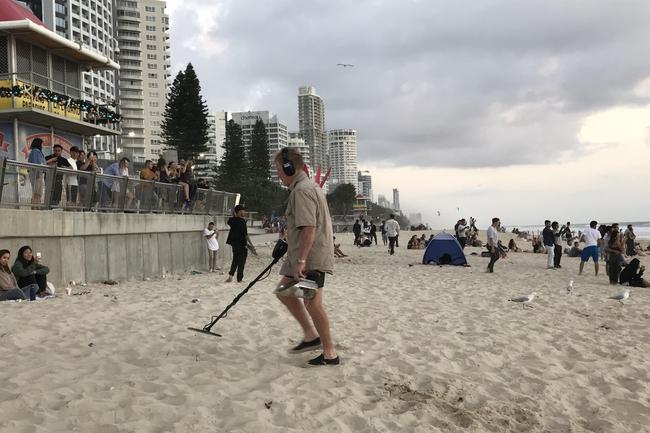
{"left": 298, "top": 86, "right": 324, "bottom": 169}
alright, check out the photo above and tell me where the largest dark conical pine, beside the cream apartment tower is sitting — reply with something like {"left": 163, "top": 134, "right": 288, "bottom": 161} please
{"left": 160, "top": 63, "right": 208, "bottom": 159}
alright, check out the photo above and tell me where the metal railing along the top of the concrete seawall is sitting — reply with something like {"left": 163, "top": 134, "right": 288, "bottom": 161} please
{"left": 0, "top": 158, "right": 238, "bottom": 215}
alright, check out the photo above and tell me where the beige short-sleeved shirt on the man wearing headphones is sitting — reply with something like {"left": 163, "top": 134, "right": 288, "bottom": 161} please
{"left": 280, "top": 172, "right": 334, "bottom": 276}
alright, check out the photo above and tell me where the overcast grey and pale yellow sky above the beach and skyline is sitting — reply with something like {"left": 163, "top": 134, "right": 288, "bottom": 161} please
{"left": 167, "top": 0, "right": 650, "bottom": 227}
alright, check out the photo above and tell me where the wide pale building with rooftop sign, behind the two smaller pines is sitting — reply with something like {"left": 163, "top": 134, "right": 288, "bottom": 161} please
{"left": 232, "top": 111, "right": 289, "bottom": 180}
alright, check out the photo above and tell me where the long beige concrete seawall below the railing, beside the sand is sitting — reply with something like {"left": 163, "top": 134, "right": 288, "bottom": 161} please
{"left": 0, "top": 209, "right": 231, "bottom": 287}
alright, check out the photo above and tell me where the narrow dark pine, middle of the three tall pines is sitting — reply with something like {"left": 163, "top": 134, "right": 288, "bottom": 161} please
{"left": 217, "top": 119, "right": 249, "bottom": 192}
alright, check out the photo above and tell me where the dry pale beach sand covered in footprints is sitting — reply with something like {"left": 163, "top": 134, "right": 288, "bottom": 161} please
{"left": 0, "top": 233, "right": 650, "bottom": 433}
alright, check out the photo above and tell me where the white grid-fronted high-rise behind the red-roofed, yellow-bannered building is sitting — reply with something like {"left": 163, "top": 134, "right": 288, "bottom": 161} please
{"left": 32, "top": 0, "right": 117, "bottom": 158}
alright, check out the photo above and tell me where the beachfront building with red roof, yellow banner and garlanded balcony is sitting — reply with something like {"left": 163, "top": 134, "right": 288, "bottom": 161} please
{"left": 0, "top": 0, "right": 120, "bottom": 161}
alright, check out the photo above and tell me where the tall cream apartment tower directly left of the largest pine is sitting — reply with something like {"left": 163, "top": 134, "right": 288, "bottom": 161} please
{"left": 115, "top": 0, "right": 171, "bottom": 162}
